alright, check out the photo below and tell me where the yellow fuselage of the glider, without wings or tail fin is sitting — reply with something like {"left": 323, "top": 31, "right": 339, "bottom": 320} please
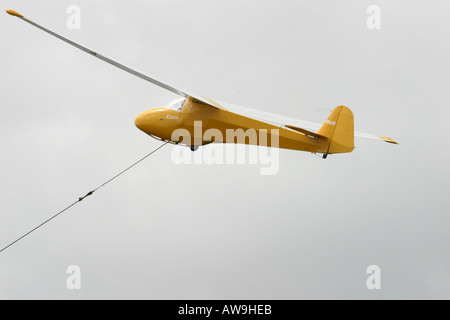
{"left": 135, "top": 99, "right": 329, "bottom": 153}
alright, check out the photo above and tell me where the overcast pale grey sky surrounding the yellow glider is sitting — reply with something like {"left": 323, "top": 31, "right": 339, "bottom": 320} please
{"left": 0, "top": 0, "right": 450, "bottom": 299}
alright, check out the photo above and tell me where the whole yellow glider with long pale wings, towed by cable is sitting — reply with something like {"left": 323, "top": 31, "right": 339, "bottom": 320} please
{"left": 6, "top": 9, "right": 397, "bottom": 158}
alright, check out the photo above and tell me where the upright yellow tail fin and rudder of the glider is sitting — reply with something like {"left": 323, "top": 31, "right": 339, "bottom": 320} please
{"left": 317, "top": 106, "right": 355, "bottom": 156}
